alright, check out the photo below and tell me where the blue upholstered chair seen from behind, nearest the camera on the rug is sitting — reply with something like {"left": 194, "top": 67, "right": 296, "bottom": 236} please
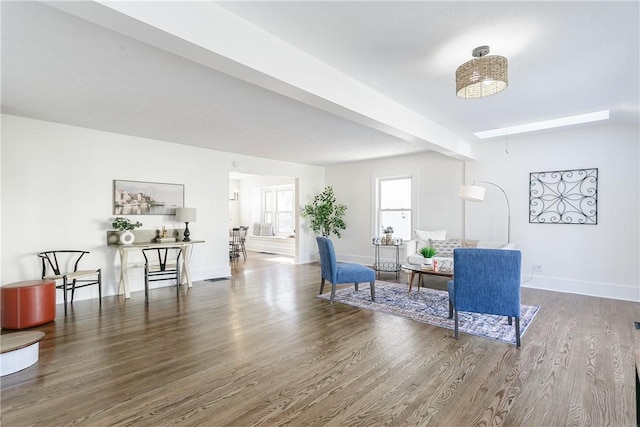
{"left": 449, "top": 248, "right": 521, "bottom": 347}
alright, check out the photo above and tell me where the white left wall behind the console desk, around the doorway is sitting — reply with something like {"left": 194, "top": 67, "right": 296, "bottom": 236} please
{"left": 1, "top": 115, "right": 324, "bottom": 301}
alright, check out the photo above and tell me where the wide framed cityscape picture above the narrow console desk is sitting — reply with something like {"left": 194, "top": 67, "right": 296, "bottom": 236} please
{"left": 113, "top": 179, "right": 184, "bottom": 215}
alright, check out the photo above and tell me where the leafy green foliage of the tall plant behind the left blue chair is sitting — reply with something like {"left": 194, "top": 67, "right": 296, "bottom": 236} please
{"left": 301, "top": 186, "right": 347, "bottom": 238}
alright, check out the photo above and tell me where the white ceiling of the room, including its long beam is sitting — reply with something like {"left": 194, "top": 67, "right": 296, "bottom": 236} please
{"left": 1, "top": 1, "right": 640, "bottom": 165}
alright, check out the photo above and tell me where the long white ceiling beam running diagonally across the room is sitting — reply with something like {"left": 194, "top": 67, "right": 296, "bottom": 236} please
{"left": 47, "top": 1, "right": 474, "bottom": 160}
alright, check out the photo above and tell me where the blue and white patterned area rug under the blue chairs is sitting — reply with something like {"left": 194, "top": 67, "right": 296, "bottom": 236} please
{"left": 319, "top": 280, "right": 540, "bottom": 344}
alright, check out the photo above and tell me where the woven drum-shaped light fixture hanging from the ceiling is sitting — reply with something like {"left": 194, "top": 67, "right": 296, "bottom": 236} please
{"left": 456, "top": 46, "right": 509, "bottom": 99}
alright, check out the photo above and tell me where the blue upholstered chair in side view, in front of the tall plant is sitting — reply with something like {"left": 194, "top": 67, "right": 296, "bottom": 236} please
{"left": 316, "top": 237, "right": 376, "bottom": 302}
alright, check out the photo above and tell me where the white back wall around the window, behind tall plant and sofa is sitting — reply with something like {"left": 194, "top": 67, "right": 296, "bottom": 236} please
{"left": 326, "top": 153, "right": 464, "bottom": 265}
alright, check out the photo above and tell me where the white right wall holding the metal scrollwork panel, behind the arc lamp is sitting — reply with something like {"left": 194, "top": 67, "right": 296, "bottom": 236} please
{"left": 465, "top": 125, "right": 640, "bottom": 301}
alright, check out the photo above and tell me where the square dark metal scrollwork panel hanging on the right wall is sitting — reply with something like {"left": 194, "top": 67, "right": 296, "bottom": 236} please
{"left": 529, "top": 168, "right": 598, "bottom": 225}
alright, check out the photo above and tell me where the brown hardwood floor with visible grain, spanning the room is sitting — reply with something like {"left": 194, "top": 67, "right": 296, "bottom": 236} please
{"left": 1, "top": 253, "right": 640, "bottom": 427}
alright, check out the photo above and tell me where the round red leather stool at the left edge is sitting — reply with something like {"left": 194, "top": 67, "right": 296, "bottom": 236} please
{"left": 0, "top": 280, "right": 56, "bottom": 329}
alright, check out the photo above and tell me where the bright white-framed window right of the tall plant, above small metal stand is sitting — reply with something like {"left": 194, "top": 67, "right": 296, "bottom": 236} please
{"left": 375, "top": 177, "right": 412, "bottom": 240}
